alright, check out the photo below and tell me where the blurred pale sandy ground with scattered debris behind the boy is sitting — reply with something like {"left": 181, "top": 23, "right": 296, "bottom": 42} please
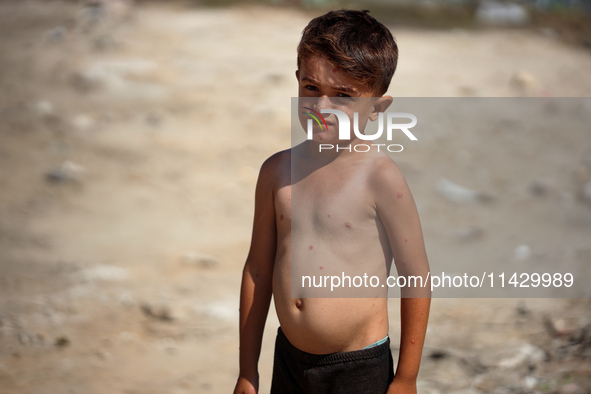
{"left": 0, "top": 0, "right": 591, "bottom": 394}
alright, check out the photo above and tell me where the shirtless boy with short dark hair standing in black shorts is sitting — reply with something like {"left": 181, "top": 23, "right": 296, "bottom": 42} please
{"left": 234, "top": 10, "right": 430, "bottom": 393}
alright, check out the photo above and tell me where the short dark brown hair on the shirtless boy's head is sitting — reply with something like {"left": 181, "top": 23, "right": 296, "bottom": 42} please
{"left": 298, "top": 10, "right": 398, "bottom": 96}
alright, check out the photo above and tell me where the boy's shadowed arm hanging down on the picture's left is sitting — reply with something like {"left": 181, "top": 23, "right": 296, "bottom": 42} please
{"left": 234, "top": 158, "right": 277, "bottom": 394}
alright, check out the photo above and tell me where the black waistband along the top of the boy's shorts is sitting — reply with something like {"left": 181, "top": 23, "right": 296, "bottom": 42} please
{"left": 277, "top": 327, "right": 390, "bottom": 365}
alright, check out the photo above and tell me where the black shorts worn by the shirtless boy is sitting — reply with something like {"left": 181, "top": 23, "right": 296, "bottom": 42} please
{"left": 271, "top": 327, "right": 394, "bottom": 394}
